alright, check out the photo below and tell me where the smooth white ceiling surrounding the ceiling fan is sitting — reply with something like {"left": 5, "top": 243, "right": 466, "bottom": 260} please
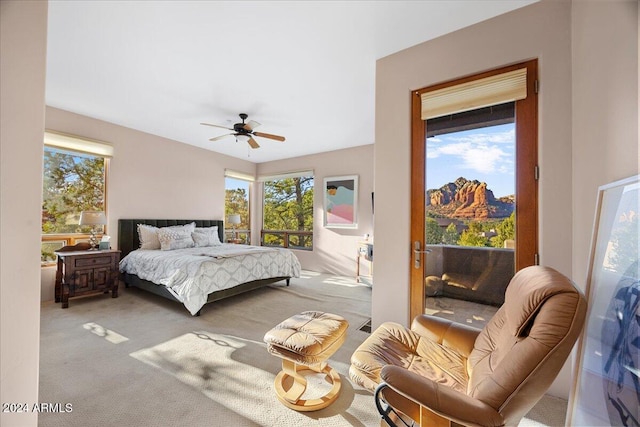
{"left": 46, "top": 0, "right": 535, "bottom": 163}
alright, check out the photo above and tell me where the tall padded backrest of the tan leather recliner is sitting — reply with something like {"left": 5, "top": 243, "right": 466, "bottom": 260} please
{"left": 467, "top": 266, "right": 587, "bottom": 425}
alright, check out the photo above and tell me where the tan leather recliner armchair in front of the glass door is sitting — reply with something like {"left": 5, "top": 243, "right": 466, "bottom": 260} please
{"left": 349, "top": 266, "right": 587, "bottom": 426}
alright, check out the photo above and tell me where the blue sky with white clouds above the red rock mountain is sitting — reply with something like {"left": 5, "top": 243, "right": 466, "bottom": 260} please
{"left": 426, "top": 123, "right": 515, "bottom": 197}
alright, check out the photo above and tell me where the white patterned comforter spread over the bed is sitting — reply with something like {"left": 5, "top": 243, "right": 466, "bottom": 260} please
{"left": 120, "top": 243, "right": 300, "bottom": 314}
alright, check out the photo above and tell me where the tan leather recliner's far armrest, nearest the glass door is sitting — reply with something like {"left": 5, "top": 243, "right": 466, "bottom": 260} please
{"left": 411, "top": 314, "right": 480, "bottom": 357}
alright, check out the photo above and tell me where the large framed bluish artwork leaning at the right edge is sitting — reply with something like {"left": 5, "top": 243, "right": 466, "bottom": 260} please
{"left": 567, "top": 175, "right": 640, "bottom": 426}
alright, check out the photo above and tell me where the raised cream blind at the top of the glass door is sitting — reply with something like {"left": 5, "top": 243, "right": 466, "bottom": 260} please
{"left": 421, "top": 68, "right": 527, "bottom": 120}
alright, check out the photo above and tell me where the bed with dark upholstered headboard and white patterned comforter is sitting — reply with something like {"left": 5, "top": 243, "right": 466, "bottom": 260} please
{"left": 118, "top": 219, "right": 300, "bottom": 315}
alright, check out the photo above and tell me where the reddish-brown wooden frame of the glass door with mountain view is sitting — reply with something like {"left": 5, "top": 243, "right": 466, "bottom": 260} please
{"left": 409, "top": 59, "right": 538, "bottom": 322}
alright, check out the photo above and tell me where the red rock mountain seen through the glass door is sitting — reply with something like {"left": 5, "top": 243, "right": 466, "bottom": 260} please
{"left": 426, "top": 177, "right": 514, "bottom": 219}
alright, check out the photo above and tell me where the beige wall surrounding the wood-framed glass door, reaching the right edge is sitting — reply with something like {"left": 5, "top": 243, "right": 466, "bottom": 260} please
{"left": 372, "top": 0, "right": 638, "bottom": 397}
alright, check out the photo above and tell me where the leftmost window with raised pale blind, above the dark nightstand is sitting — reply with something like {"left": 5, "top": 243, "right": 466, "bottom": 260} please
{"left": 41, "top": 132, "right": 112, "bottom": 264}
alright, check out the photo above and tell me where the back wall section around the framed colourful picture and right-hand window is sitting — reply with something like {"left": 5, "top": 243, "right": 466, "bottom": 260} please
{"left": 254, "top": 144, "right": 375, "bottom": 276}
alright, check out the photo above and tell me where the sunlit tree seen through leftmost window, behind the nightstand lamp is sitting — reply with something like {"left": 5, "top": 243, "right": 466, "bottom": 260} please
{"left": 42, "top": 148, "right": 104, "bottom": 234}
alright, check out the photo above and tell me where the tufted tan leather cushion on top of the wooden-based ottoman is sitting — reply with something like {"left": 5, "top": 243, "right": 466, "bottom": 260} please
{"left": 264, "top": 311, "right": 349, "bottom": 365}
